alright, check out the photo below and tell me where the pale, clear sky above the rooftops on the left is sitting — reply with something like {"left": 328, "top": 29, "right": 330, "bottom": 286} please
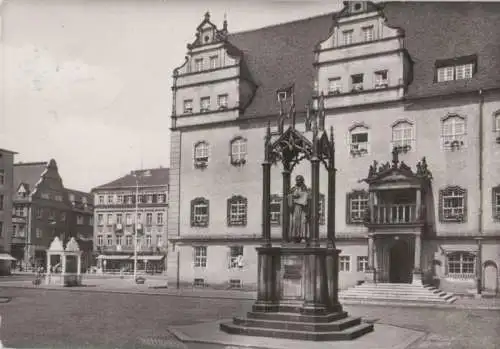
{"left": 0, "top": 0, "right": 341, "bottom": 191}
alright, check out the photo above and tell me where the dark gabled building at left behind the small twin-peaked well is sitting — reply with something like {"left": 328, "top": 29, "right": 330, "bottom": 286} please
{"left": 11, "top": 159, "right": 93, "bottom": 270}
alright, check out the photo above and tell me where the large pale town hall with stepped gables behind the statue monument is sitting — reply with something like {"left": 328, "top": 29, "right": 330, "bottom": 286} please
{"left": 168, "top": 2, "right": 500, "bottom": 293}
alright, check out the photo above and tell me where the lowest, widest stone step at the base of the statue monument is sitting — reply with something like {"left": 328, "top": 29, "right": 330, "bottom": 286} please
{"left": 220, "top": 323, "right": 373, "bottom": 341}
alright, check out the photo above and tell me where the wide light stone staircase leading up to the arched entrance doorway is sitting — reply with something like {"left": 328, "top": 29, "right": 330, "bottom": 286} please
{"left": 339, "top": 283, "right": 457, "bottom": 304}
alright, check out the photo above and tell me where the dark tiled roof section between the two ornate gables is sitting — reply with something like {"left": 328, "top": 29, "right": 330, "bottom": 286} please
{"left": 228, "top": 14, "right": 333, "bottom": 117}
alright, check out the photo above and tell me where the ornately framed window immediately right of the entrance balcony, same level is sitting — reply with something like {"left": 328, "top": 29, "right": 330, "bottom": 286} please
{"left": 439, "top": 186, "right": 467, "bottom": 223}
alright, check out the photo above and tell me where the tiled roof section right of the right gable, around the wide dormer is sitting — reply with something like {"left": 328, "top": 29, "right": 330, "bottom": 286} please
{"left": 384, "top": 1, "right": 500, "bottom": 97}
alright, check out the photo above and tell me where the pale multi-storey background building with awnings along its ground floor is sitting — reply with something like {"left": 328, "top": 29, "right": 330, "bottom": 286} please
{"left": 92, "top": 167, "right": 169, "bottom": 273}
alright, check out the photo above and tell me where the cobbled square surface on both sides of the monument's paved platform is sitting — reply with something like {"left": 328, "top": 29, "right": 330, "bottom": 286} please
{"left": 0, "top": 288, "right": 500, "bottom": 349}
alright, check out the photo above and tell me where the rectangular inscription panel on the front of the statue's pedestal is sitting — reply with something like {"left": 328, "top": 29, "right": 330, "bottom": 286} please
{"left": 281, "top": 256, "right": 303, "bottom": 299}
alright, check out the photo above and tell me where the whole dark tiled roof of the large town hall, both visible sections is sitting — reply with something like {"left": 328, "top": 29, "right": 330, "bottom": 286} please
{"left": 228, "top": 2, "right": 500, "bottom": 118}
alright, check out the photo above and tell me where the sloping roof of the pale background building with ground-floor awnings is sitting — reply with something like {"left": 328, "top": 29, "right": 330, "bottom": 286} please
{"left": 92, "top": 167, "right": 169, "bottom": 191}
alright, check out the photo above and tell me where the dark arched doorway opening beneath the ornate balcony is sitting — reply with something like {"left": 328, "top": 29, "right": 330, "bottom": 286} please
{"left": 389, "top": 239, "right": 413, "bottom": 283}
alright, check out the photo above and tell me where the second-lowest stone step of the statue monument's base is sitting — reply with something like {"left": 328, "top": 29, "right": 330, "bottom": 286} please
{"left": 233, "top": 316, "right": 361, "bottom": 332}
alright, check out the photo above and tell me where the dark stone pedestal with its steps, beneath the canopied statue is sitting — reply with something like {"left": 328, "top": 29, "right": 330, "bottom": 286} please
{"left": 220, "top": 244, "right": 373, "bottom": 341}
